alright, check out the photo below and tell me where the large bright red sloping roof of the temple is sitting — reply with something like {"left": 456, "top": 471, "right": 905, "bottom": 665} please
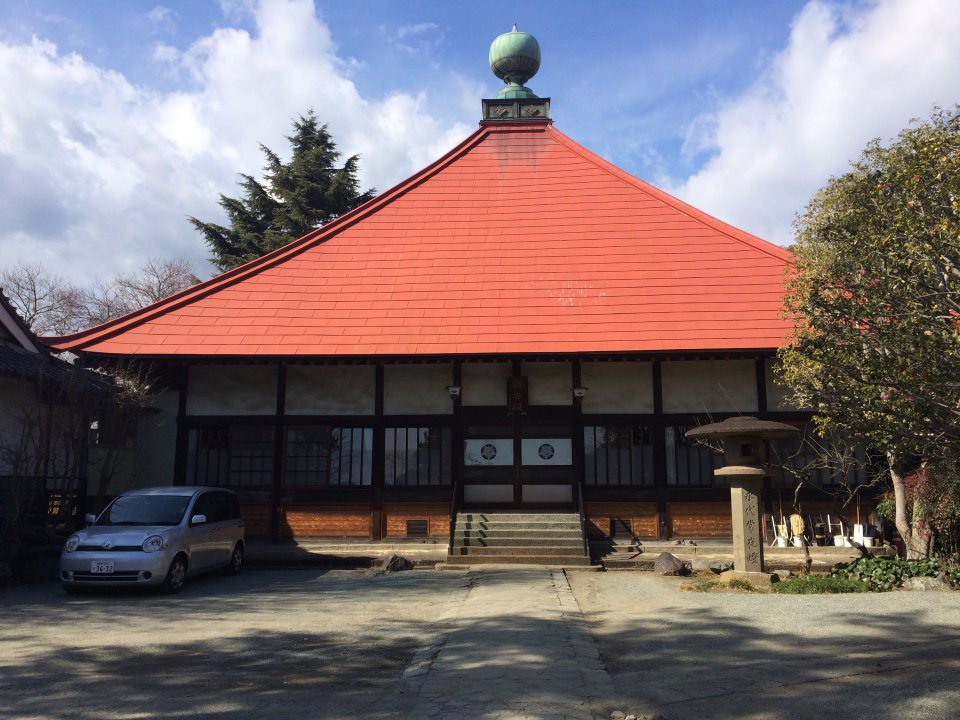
{"left": 47, "top": 122, "right": 791, "bottom": 356}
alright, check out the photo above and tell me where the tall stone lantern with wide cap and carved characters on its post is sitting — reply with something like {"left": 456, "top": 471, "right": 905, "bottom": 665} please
{"left": 686, "top": 417, "right": 799, "bottom": 584}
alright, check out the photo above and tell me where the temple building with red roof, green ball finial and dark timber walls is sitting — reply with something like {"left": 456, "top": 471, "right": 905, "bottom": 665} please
{"left": 47, "top": 29, "right": 828, "bottom": 539}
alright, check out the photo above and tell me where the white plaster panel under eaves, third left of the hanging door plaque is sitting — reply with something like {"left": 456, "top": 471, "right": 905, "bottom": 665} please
{"left": 284, "top": 365, "right": 377, "bottom": 415}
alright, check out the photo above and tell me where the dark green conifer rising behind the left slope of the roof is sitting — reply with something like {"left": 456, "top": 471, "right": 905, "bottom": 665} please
{"left": 190, "top": 110, "right": 374, "bottom": 270}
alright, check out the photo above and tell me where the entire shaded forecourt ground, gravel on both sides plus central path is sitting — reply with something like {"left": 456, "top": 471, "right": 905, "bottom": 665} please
{"left": 0, "top": 568, "right": 960, "bottom": 720}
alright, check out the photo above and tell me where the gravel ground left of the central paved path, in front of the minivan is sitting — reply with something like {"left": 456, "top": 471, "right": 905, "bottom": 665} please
{"left": 0, "top": 570, "right": 462, "bottom": 720}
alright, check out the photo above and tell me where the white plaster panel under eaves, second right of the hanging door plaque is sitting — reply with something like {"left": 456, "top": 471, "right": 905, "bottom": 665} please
{"left": 580, "top": 362, "right": 653, "bottom": 413}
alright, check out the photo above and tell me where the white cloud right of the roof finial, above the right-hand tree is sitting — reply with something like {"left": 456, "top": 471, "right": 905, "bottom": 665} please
{"left": 672, "top": 0, "right": 960, "bottom": 244}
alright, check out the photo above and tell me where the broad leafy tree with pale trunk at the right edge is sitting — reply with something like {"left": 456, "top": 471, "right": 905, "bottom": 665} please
{"left": 780, "top": 106, "right": 960, "bottom": 557}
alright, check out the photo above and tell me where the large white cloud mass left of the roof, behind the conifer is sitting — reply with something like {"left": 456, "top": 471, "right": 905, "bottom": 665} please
{"left": 0, "top": 0, "right": 472, "bottom": 282}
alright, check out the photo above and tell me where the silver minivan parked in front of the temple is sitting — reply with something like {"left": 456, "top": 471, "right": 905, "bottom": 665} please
{"left": 60, "top": 486, "right": 244, "bottom": 593}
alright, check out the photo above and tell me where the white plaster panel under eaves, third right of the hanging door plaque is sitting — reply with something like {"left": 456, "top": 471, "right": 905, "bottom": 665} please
{"left": 662, "top": 360, "right": 757, "bottom": 413}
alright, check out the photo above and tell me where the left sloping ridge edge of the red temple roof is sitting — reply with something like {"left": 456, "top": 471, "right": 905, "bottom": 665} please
{"left": 44, "top": 125, "right": 496, "bottom": 350}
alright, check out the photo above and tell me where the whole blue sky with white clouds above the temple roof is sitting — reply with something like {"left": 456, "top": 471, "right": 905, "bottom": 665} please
{"left": 0, "top": 0, "right": 960, "bottom": 282}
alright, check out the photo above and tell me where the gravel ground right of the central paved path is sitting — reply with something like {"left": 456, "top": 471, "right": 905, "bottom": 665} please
{"left": 569, "top": 572, "right": 960, "bottom": 720}
